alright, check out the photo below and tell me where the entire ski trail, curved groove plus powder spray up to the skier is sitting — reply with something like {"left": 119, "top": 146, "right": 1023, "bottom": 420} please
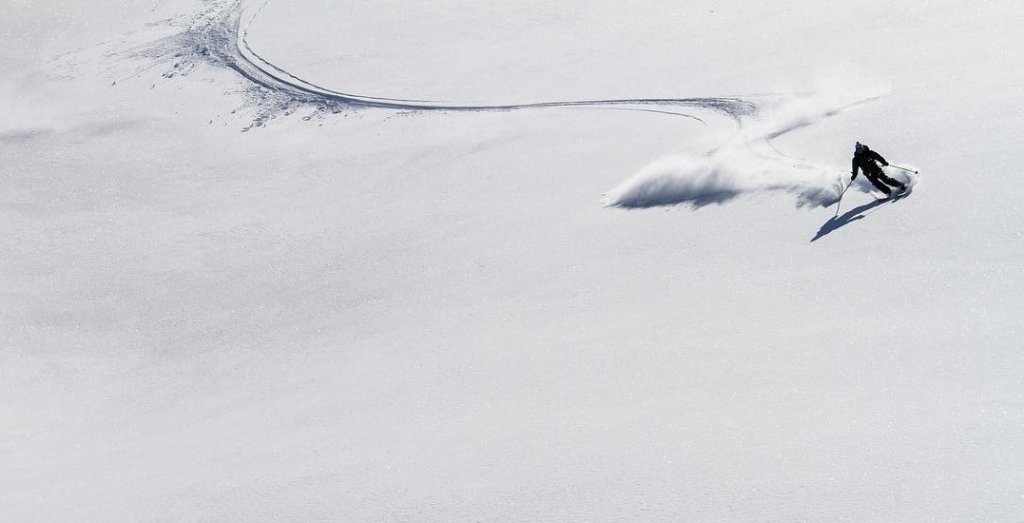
{"left": 128, "top": 0, "right": 879, "bottom": 214}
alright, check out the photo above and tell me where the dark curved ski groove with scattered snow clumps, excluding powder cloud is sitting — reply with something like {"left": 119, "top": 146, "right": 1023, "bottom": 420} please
{"left": 130, "top": 0, "right": 758, "bottom": 129}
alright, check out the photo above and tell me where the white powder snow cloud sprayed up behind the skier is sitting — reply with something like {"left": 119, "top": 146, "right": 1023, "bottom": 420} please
{"left": 604, "top": 82, "right": 878, "bottom": 209}
